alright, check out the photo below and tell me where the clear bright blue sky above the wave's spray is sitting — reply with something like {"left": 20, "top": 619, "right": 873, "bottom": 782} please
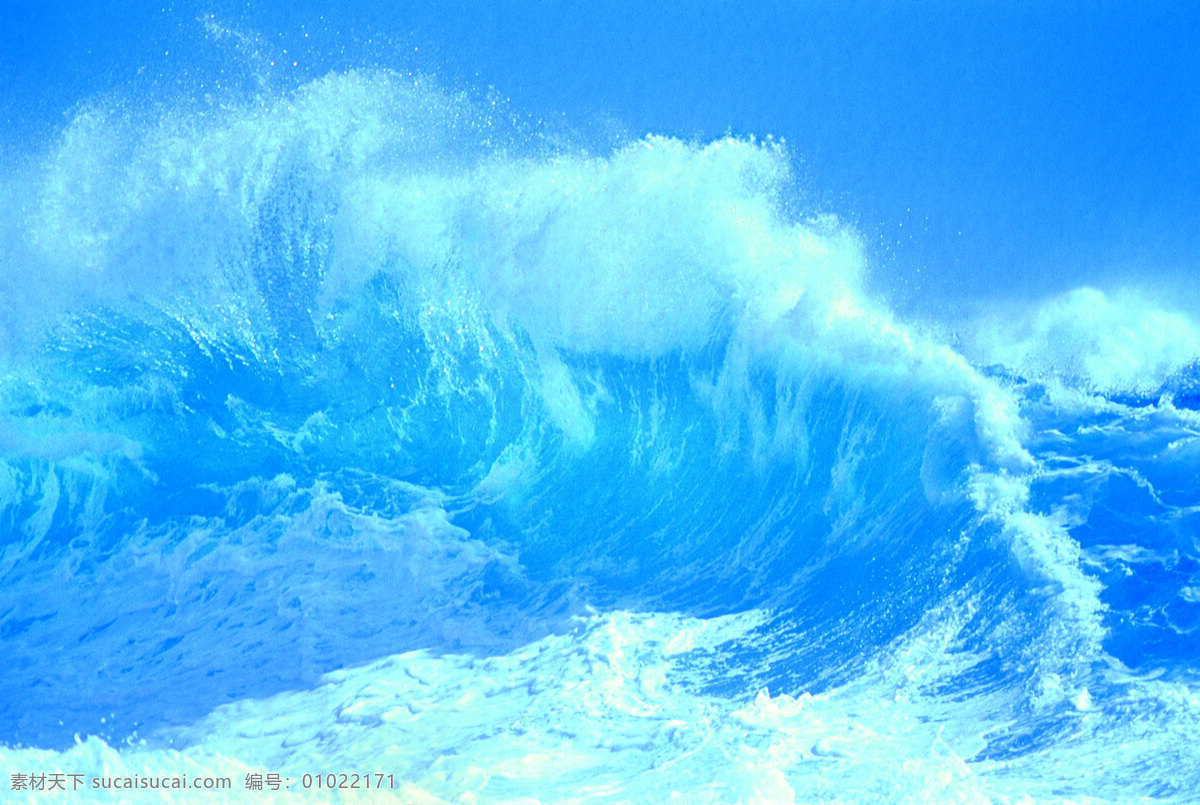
{"left": 0, "top": 0, "right": 1200, "bottom": 310}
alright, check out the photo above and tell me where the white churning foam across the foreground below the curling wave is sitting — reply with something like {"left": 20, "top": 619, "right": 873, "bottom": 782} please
{"left": 7, "top": 600, "right": 1200, "bottom": 805}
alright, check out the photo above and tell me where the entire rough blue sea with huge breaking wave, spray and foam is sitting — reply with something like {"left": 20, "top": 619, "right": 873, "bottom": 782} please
{"left": 0, "top": 9, "right": 1200, "bottom": 803}
